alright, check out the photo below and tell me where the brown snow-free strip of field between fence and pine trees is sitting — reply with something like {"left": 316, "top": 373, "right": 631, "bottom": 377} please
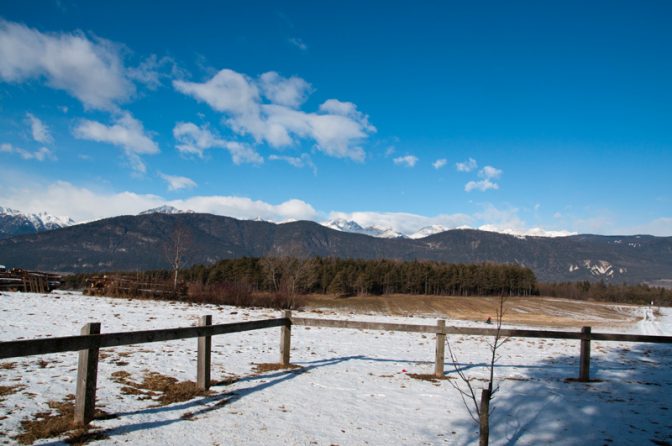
{"left": 305, "top": 294, "right": 641, "bottom": 327}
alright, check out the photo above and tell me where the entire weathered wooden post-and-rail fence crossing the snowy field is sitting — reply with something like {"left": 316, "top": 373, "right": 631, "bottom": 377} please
{"left": 0, "top": 311, "right": 672, "bottom": 425}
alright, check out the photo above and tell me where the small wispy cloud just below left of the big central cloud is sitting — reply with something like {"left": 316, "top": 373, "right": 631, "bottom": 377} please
{"left": 173, "top": 122, "right": 264, "bottom": 164}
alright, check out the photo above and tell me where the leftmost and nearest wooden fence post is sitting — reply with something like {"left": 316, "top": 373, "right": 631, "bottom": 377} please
{"left": 74, "top": 322, "right": 100, "bottom": 426}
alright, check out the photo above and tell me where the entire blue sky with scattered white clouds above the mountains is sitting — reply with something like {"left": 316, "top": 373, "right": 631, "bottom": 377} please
{"left": 0, "top": 0, "right": 672, "bottom": 236}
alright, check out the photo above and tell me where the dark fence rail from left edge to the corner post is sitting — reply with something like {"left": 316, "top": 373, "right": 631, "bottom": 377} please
{"left": 0, "top": 318, "right": 289, "bottom": 359}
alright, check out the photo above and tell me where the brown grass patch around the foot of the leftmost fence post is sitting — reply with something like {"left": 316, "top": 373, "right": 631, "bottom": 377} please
{"left": 14, "top": 395, "right": 111, "bottom": 445}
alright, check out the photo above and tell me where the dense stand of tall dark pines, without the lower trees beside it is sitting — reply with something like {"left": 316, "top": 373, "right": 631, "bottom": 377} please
{"left": 180, "top": 257, "right": 538, "bottom": 296}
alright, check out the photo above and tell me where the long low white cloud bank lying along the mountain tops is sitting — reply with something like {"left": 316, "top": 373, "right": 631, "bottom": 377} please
{"left": 0, "top": 174, "right": 588, "bottom": 237}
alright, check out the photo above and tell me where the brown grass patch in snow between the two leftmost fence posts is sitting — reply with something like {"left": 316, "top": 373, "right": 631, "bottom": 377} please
{"left": 112, "top": 370, "right": 212, "bottom": 406}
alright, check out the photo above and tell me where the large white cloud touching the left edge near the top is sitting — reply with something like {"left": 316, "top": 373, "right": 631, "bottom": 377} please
{"left": 0, "top": 19, "right": 135, "bottom": 110}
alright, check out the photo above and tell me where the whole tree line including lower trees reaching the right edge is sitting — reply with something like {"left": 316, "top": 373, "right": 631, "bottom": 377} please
{"left": 64, "top": 257, "right": 672, "bottom": 306}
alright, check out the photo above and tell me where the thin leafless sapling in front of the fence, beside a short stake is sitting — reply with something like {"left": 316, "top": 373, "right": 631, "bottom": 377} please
{"left": 447, "top": 295, "right": 508, "bottom": 446}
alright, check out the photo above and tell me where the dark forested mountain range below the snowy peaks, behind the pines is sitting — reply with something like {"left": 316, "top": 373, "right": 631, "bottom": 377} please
{"left": 0, "top": 208, "right": 672, "bottom": 283}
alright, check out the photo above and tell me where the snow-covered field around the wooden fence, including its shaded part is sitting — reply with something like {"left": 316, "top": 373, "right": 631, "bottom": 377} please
{"left": 0, "top": 292, "right": 672, "bottom": 445}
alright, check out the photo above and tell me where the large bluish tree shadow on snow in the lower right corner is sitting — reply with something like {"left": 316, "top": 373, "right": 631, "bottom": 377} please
{"left": 447, "top": 343, "right": 672, "bottom": 446}
